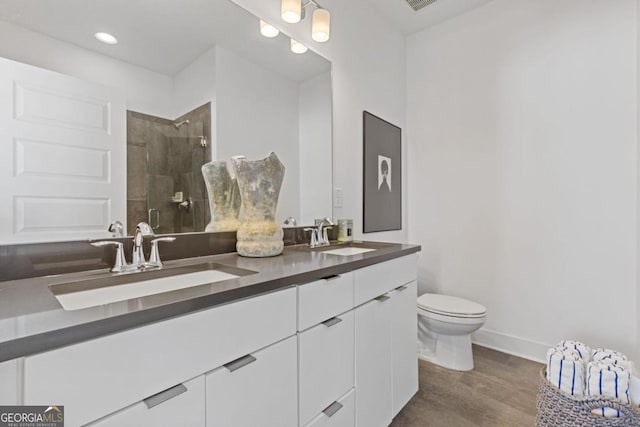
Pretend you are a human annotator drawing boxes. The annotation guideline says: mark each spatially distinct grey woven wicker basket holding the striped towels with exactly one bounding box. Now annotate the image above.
[536,368,640,427]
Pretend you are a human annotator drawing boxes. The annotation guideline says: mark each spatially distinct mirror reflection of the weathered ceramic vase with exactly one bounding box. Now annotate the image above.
[202,160,242,231]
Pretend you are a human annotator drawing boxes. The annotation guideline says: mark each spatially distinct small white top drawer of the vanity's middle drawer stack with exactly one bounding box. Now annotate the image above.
[298,272,353,331]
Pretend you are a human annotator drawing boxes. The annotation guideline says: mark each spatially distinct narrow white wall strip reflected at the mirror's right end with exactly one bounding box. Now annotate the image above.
[298,73,332,225]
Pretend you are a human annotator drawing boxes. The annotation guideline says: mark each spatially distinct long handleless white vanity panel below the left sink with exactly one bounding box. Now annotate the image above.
[24,288,296,425]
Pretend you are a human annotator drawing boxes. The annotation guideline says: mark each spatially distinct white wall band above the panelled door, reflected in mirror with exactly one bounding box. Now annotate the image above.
[0,21,173,117]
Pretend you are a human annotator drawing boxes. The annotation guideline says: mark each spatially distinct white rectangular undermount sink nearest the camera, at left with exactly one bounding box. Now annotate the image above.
[49,264,254,310]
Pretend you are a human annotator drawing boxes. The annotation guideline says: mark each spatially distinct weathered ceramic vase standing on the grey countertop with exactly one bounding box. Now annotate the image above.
[231,152,284,257]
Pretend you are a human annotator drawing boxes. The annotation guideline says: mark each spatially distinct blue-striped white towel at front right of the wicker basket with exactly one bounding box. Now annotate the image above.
[587,361,631,403]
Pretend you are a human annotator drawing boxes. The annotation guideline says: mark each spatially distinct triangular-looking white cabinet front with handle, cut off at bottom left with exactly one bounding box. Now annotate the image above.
[89,375,205,427]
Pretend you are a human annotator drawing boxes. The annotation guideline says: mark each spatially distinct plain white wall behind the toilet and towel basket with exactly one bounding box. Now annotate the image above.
[407,0,638,358]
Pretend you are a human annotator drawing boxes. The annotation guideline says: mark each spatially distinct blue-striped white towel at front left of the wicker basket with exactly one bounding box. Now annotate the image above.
[547,347,585,396]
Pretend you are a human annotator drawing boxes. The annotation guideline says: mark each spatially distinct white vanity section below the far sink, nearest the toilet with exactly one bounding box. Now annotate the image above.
[354,256,418,427]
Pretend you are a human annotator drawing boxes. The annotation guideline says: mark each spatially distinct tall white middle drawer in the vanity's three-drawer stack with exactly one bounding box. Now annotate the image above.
[298,310,354,425]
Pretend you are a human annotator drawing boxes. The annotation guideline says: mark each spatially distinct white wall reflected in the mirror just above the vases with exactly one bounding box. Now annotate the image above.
[213,46,300,223]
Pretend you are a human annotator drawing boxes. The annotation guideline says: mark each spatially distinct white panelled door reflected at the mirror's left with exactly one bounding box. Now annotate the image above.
[0,58,126,244]
